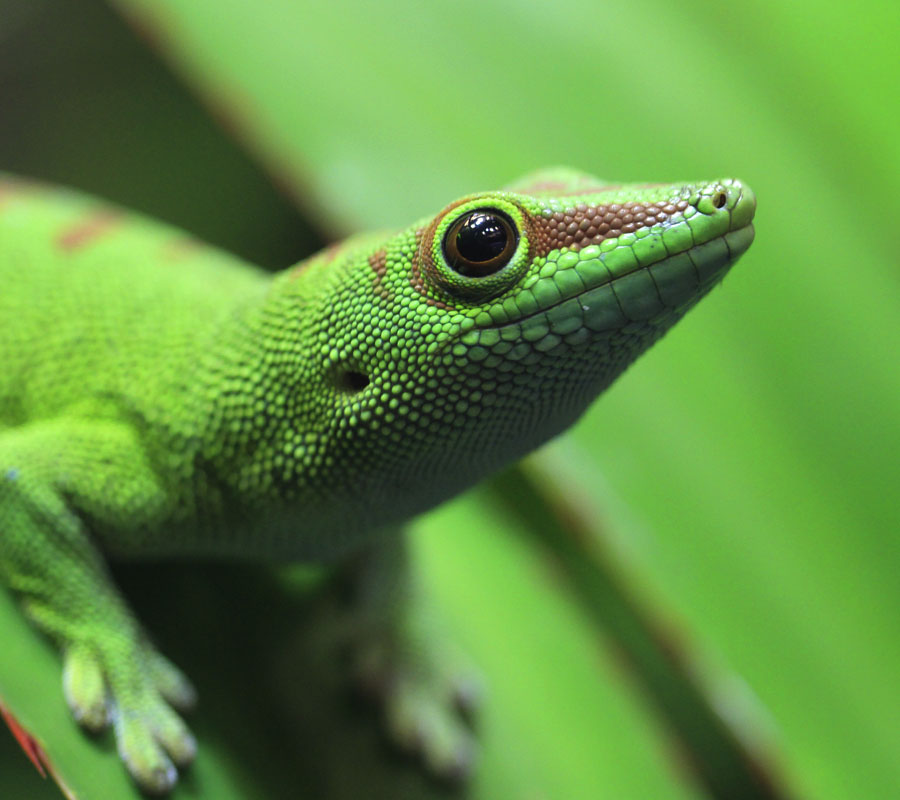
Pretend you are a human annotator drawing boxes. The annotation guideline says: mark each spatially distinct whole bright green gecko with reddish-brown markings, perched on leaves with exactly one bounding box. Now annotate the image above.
[0,169,756,793]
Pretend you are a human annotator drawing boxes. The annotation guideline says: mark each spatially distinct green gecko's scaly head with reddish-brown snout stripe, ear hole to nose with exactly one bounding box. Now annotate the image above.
[282,170,755,513]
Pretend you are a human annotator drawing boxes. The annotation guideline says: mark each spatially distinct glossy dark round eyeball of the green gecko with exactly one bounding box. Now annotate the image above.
[444,208,519,278]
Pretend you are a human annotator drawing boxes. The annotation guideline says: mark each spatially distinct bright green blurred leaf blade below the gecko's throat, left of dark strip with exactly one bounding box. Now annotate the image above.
[416,488,702,800]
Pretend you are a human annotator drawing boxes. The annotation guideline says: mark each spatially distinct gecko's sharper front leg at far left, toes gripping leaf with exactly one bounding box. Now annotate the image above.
[0,420,196,793]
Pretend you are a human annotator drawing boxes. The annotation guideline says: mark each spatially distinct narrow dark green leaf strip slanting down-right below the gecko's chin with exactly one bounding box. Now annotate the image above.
[490,456,788,800]
